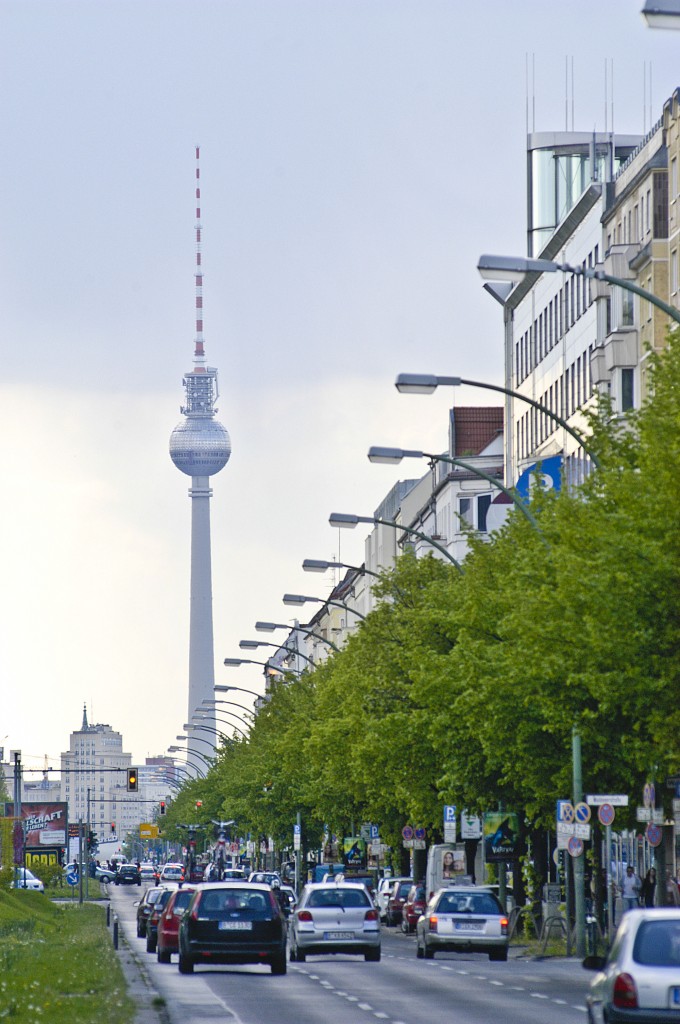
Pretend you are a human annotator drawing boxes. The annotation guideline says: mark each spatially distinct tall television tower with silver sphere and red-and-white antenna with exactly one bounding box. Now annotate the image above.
[170,146,231,768]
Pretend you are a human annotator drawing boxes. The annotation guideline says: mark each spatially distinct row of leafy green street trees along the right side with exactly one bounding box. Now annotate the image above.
[166,339,680,897]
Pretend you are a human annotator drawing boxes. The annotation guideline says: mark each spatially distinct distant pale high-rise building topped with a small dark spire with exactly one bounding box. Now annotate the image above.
[61,708,142,841]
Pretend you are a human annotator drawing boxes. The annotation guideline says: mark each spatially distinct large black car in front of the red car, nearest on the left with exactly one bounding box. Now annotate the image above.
[177,882,287,974]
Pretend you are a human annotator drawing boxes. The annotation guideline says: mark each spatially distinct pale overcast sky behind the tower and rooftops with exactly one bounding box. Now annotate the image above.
[0,0,680,764]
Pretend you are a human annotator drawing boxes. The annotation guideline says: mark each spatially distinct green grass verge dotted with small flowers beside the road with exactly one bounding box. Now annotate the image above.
[0,891,135,1024]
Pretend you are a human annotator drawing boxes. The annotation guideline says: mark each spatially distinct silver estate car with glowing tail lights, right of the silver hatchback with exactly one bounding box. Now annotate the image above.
[416,886,508,961]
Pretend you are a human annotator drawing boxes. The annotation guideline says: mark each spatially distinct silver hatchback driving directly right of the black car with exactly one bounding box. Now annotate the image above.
[289,882,380,963]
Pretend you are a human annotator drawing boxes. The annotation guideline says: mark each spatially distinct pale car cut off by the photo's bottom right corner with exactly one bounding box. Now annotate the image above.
[584,907,680,1024]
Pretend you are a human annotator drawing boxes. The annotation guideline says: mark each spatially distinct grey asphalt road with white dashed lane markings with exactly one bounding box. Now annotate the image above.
[109,886,591,1024]
